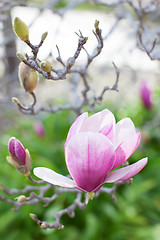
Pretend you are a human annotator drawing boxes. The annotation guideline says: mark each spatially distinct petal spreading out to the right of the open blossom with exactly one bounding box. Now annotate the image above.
[104,157,148,183]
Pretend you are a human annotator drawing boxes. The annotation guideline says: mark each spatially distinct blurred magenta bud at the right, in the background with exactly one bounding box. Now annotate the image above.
[140,80,153,109]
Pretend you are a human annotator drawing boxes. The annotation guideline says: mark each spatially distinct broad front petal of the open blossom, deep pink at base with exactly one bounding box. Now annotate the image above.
[65,132,115,192]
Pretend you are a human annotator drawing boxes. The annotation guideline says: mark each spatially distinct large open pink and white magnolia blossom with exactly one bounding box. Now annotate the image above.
[34,109,147,192]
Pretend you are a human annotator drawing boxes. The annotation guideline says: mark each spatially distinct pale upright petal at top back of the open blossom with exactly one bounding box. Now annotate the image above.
[80,109,115,132]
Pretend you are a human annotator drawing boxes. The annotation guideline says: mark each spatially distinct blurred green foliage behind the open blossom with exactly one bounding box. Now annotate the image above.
[0,85,160,240]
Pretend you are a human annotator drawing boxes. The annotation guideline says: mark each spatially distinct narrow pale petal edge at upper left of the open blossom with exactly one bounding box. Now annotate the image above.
[65,112,88,147]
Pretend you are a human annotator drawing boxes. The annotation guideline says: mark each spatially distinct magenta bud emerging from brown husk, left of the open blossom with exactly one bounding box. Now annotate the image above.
[7,137,31,176]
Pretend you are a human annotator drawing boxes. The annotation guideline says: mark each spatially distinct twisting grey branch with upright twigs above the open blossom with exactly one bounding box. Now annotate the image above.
[12,21,120,115]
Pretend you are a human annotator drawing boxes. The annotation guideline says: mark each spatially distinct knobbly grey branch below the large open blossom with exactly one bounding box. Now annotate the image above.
[0,173,131,229]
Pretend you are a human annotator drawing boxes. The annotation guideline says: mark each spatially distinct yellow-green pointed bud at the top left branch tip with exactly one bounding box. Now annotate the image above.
[14,17,29,41]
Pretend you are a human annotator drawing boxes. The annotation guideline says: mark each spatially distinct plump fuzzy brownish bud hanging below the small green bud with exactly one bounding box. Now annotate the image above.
[19,62,38,93]
